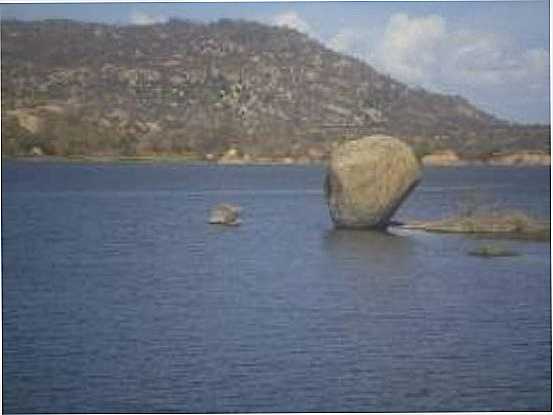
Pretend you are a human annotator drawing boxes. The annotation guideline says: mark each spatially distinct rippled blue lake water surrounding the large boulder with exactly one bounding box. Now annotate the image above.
[2,161,551,413]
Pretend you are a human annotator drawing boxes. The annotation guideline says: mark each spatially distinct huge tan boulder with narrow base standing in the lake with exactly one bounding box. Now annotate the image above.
[325,135,421,228]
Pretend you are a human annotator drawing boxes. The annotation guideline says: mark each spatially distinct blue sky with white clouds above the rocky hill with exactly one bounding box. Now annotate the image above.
[0,0,550,123]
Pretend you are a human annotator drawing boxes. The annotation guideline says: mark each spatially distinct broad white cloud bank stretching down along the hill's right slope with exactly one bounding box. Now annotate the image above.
[326,13,549,120]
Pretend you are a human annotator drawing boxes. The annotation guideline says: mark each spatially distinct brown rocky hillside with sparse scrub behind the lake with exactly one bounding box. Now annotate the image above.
[1,20,549,160]
